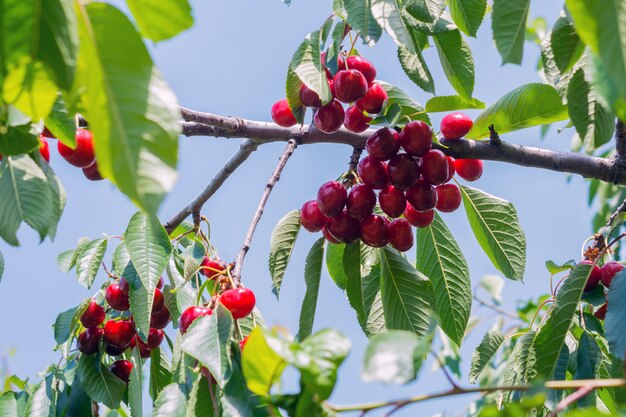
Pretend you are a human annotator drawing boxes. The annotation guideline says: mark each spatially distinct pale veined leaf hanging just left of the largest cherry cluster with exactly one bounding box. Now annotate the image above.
[269,210,300,298]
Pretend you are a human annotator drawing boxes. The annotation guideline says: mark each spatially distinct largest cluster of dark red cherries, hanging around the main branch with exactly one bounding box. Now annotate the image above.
[300,113,483,251]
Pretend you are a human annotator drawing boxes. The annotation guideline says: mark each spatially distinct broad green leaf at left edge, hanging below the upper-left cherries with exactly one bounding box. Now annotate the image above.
[0,155,52,246]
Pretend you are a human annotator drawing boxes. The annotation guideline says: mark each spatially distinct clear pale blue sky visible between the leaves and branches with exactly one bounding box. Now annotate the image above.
[0,0,592,417]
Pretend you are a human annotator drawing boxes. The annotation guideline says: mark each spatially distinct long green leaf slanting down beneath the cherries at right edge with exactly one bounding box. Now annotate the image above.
[533,265,591,378]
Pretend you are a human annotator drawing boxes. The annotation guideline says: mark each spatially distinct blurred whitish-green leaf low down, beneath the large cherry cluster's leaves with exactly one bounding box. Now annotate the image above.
[363,330,430,384]
